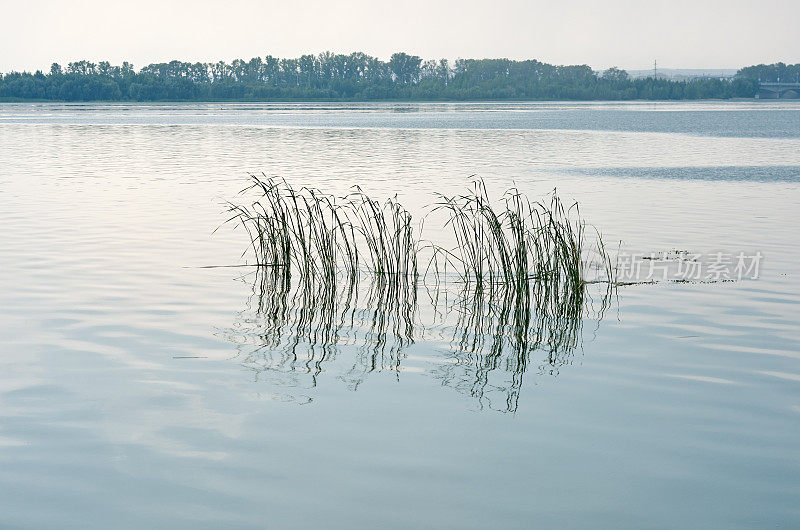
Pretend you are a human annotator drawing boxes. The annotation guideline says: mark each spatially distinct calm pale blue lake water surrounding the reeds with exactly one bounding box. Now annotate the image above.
[0,102,800,528]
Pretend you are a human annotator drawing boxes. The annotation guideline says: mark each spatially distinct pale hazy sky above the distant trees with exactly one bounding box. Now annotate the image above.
[0,0,800,72]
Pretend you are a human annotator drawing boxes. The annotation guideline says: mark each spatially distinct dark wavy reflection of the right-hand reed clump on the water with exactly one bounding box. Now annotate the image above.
[430,276,611,412]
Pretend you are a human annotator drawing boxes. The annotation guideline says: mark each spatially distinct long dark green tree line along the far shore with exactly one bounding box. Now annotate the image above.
[0,52,788,101]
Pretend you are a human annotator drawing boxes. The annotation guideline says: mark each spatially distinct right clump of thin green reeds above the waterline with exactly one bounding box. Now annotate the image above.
[434,180,611,292]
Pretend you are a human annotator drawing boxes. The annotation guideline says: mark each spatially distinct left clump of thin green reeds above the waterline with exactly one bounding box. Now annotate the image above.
[229,175,417,287]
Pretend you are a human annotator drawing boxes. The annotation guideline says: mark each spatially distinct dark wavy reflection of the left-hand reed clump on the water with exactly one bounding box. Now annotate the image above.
[231,268,418,389]
